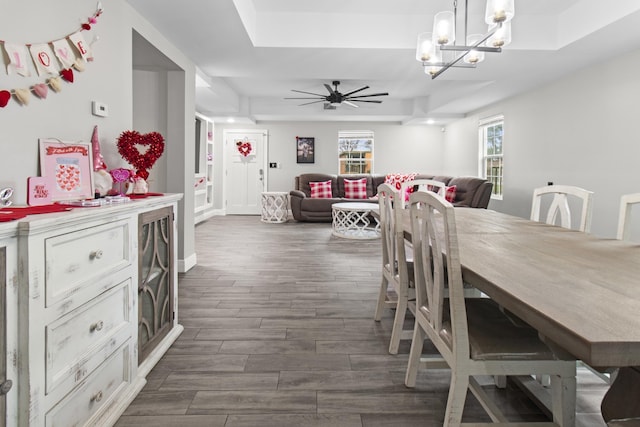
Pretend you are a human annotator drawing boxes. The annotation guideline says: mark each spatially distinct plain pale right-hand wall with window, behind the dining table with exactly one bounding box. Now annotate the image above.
[445,47,640,241]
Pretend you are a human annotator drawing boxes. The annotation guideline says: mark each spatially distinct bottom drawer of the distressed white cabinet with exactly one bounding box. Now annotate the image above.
[45,342,131,427]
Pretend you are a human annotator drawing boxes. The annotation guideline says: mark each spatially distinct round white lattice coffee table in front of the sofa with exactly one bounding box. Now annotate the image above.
[331,202,380,239]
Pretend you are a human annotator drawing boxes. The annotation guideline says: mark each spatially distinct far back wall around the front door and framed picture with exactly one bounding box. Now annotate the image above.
[214,122,444,208]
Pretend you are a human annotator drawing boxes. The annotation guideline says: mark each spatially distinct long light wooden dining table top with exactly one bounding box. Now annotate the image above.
[401,208,640,368]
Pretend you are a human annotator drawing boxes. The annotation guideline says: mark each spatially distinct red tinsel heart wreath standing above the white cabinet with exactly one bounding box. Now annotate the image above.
[118,130,164,179]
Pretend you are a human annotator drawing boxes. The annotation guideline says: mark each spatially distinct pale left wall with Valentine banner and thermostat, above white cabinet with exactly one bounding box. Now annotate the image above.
[0,0,195,268]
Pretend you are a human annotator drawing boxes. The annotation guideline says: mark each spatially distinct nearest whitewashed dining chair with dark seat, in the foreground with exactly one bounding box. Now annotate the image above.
[405,192,576,426]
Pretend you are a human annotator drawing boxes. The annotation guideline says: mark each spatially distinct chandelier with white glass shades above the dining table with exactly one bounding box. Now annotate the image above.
[416,0,514,79]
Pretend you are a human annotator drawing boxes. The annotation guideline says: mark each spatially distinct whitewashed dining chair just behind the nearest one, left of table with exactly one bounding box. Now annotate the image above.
[374,184,415,354]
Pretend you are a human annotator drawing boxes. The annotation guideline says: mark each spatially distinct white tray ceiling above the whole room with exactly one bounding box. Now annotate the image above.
[128,0,640,124]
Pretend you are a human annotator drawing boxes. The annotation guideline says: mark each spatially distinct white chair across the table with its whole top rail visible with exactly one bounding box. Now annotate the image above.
[531,185,593,233]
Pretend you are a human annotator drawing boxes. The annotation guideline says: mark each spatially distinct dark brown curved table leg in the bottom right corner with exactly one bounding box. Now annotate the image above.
[600,366,640,427]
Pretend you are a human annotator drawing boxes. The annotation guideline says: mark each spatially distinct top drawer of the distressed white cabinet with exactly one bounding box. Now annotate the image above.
[45,221,132,307]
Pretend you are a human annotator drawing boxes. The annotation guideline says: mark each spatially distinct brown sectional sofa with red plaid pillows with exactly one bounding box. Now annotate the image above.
[289,173,493,222]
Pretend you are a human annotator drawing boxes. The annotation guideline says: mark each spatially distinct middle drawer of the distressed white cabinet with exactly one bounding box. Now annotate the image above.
[46,280,133,394]
